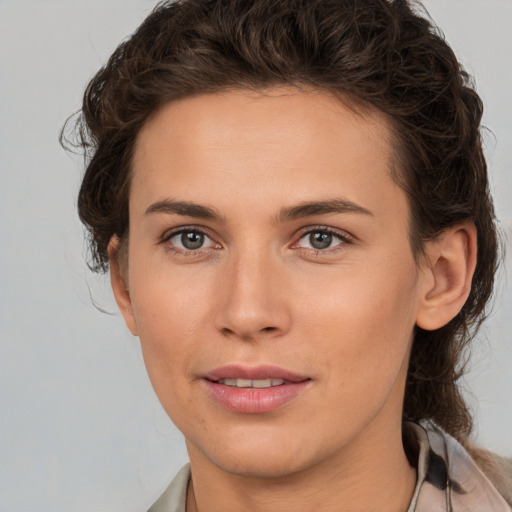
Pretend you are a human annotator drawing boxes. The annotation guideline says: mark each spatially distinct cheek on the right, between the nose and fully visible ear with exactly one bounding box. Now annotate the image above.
[296,254,417,382]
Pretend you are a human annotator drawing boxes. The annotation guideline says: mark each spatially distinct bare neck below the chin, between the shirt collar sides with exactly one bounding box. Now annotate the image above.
[187,420,416,512]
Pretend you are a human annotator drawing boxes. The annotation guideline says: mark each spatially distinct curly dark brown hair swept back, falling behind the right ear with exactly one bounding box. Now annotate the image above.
[64,0,499,441]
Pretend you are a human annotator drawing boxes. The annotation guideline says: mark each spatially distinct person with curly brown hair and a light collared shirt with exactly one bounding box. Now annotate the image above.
[64,0,512,512]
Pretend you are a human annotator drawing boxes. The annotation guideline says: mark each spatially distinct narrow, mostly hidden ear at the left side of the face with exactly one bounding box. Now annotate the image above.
[108,235,138,336]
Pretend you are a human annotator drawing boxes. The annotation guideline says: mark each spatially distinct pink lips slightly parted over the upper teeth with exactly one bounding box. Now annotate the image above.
[202,365,311,414]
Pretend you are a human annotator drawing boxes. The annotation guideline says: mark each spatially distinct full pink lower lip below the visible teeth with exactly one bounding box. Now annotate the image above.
[203,379,311,414]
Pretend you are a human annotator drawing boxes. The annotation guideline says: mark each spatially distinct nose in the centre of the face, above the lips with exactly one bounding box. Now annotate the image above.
[215,247,291,341]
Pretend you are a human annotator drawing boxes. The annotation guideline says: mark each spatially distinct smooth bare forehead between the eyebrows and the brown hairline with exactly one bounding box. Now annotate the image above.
[131,87,401,222]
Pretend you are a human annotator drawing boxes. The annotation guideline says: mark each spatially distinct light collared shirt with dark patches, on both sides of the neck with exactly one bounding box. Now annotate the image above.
[148,421,512,512]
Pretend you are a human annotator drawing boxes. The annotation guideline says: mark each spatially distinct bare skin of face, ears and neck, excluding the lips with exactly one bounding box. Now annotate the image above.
[110,88,476,512]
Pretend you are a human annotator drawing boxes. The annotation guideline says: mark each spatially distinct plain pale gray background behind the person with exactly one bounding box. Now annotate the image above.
[0,0,512,512]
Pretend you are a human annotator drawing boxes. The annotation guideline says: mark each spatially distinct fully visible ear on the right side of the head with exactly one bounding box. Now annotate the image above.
[416,222,477,331]
